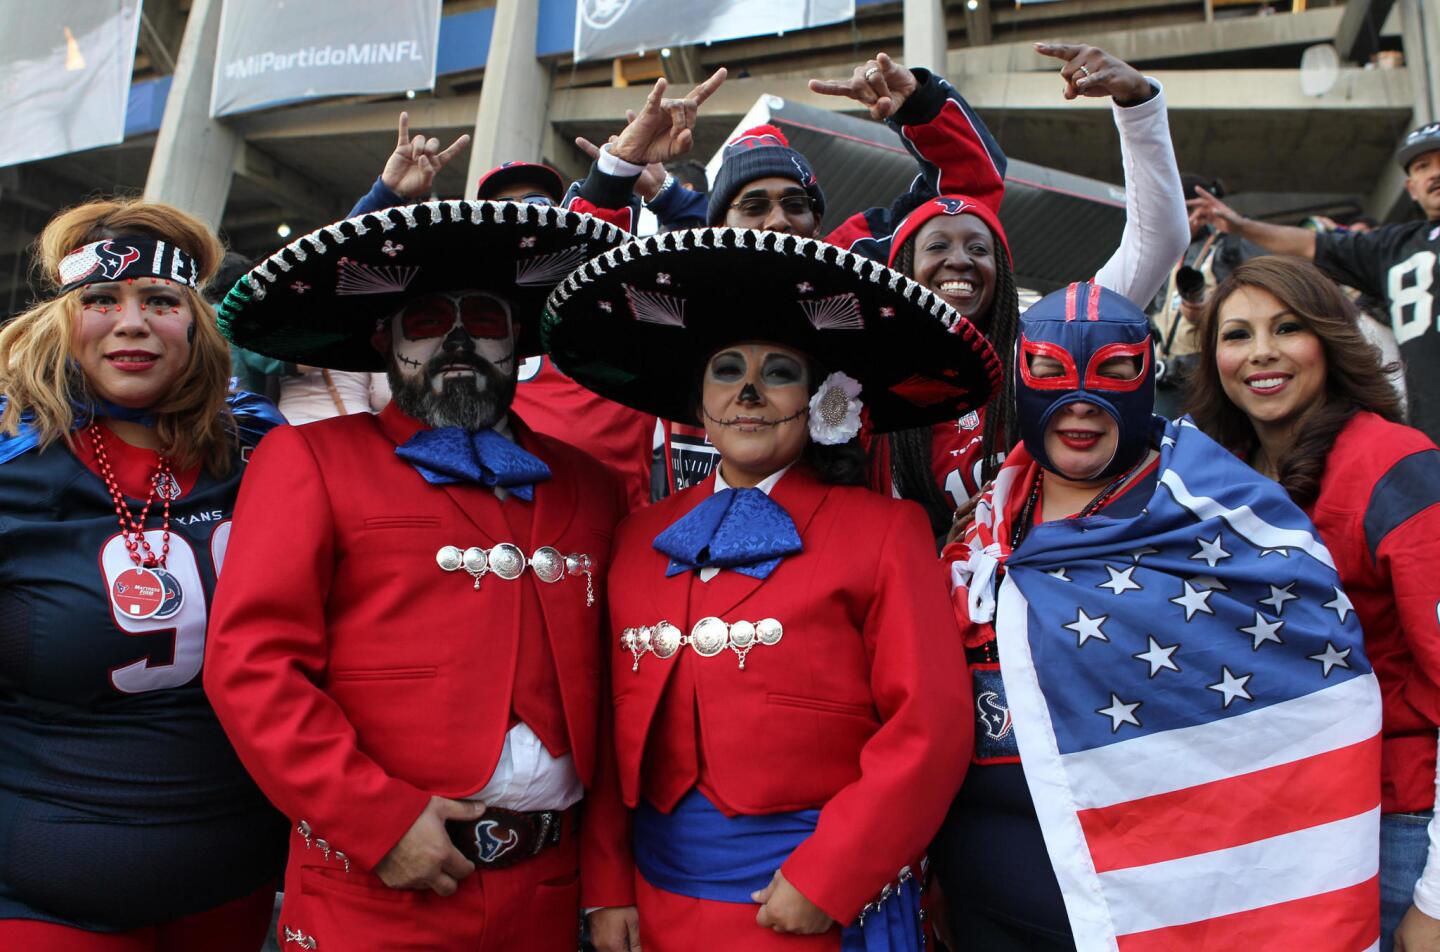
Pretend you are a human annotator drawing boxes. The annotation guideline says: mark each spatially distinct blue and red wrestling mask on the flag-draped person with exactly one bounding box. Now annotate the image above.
[1015,282,1155,478]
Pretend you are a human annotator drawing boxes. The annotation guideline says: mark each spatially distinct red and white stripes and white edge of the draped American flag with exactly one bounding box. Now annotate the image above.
[995,578,1381,952]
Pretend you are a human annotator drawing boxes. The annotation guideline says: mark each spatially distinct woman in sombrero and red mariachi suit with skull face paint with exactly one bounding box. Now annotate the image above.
[547,229,999,952]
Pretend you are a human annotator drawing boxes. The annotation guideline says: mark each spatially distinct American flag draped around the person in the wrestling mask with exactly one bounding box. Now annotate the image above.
[952,419,1381,952]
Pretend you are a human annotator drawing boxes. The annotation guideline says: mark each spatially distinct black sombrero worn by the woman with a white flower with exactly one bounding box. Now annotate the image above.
[543,228,1001,432]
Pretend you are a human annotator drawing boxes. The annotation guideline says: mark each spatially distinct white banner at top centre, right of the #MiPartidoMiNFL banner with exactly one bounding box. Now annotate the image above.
[575,0,855,62]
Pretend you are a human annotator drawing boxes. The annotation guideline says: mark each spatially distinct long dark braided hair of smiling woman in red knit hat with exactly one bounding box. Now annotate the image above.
[888,218,1020,534]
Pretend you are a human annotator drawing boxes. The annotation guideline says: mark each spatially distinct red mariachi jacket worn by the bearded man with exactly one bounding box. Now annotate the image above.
[204,405,622,879]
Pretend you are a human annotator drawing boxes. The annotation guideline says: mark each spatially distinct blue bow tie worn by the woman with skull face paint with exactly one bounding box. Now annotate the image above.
[652,490,804,579]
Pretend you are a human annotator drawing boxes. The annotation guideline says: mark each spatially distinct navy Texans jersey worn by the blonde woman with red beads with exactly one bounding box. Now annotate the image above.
[0,423,287,932]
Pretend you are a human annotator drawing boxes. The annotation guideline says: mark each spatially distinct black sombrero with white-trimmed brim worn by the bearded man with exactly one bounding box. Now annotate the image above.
[216,202,626,370]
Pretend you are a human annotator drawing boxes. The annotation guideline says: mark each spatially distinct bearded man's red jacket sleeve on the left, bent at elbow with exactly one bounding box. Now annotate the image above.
[204,426,429,868]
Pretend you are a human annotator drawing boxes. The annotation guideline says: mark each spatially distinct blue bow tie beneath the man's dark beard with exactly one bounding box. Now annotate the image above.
[395,426,550,501]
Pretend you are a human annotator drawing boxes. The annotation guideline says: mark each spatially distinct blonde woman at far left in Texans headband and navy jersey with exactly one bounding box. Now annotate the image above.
[0,200,287,952]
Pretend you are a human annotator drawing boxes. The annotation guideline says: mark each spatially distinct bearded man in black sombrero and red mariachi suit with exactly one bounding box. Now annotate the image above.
[204,202,621,952]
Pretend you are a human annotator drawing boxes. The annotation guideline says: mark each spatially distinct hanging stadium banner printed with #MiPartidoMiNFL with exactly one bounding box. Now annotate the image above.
[210,0,441,117]
